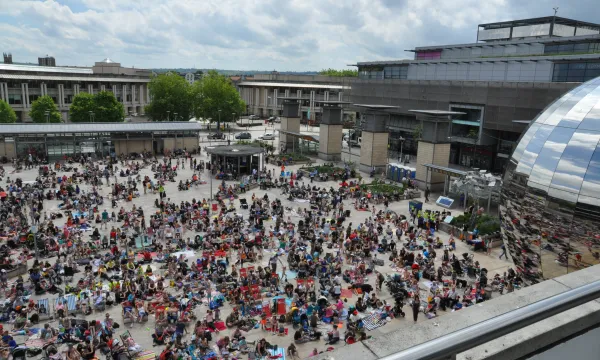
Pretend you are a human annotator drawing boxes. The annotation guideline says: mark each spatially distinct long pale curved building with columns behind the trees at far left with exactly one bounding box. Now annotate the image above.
[0,58,151,122]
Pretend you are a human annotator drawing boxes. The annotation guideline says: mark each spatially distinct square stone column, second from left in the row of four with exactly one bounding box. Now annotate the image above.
[319,103,344,161]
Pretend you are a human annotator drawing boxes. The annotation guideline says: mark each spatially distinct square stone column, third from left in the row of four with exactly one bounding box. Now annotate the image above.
[359,112,389,173]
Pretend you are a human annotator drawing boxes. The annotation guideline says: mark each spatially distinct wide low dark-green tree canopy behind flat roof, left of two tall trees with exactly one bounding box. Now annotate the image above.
[69,91,125,122]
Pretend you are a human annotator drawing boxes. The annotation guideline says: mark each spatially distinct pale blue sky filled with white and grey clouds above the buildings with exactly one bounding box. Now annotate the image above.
[0,0,600,71]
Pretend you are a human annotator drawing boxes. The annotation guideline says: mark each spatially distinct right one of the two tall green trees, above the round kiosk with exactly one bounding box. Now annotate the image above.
[192,70,246,131]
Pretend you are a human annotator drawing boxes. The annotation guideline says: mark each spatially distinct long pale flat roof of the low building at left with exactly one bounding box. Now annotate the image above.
[0,121,202,135]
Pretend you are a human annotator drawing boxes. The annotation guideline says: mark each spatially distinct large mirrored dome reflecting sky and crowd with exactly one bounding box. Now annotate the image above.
[500,77,600,284]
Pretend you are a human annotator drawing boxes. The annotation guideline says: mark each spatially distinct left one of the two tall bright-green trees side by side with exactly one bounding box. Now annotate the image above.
[145,72,192,121]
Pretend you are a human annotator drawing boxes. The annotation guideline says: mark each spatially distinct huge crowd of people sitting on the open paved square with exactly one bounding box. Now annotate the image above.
[0,151,521,360]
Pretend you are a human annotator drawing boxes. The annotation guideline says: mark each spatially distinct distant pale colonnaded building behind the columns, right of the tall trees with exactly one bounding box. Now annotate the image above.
[237,74,351,123]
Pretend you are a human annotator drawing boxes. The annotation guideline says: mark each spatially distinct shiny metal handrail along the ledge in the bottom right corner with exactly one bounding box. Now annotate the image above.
[381,281,600,360]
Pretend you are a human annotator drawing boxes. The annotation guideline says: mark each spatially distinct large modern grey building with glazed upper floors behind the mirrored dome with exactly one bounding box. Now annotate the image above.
[351,17,600,172]
